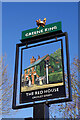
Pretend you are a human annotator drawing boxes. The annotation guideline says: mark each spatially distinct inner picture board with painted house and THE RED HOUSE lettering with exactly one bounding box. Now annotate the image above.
[20,40,66,103]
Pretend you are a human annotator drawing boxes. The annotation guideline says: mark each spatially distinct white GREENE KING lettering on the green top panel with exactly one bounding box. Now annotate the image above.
[25,26,57,37]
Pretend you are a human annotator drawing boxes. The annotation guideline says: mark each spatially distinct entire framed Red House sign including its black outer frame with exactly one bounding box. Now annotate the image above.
[12,32,72,109]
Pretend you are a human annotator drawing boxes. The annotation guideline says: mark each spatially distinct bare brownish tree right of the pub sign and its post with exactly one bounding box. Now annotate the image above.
[50,58,80,118]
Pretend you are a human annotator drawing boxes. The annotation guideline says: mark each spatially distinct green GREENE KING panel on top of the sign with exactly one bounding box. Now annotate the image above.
[22,22,62,40]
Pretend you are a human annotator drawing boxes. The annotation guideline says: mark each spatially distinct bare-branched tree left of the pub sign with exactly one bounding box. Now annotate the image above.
[0,56,17,115]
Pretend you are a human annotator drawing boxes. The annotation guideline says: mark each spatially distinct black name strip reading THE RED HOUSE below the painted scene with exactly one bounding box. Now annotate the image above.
[20,85,66,103]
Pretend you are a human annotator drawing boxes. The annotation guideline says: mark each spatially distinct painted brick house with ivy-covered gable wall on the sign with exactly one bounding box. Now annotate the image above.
[22,54,62,86]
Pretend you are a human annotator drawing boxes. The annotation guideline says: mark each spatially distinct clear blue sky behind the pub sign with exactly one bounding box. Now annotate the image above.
[2,2,78,118]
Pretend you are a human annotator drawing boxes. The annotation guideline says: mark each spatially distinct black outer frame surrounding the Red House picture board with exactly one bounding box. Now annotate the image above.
[12,32,72,109]
